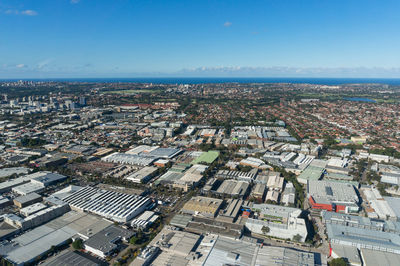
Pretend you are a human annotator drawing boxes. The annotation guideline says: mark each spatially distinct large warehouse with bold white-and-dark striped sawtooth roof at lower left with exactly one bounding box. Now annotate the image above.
[63,186,151,223]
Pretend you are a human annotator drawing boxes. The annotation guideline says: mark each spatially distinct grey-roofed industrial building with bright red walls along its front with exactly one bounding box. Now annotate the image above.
[307,180,359,213]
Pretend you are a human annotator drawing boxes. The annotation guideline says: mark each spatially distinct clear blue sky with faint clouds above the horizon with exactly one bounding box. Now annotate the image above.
[0,0,400,78]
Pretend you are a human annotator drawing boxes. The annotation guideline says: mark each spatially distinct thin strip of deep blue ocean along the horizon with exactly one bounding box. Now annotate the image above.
[0,77,400,86]
